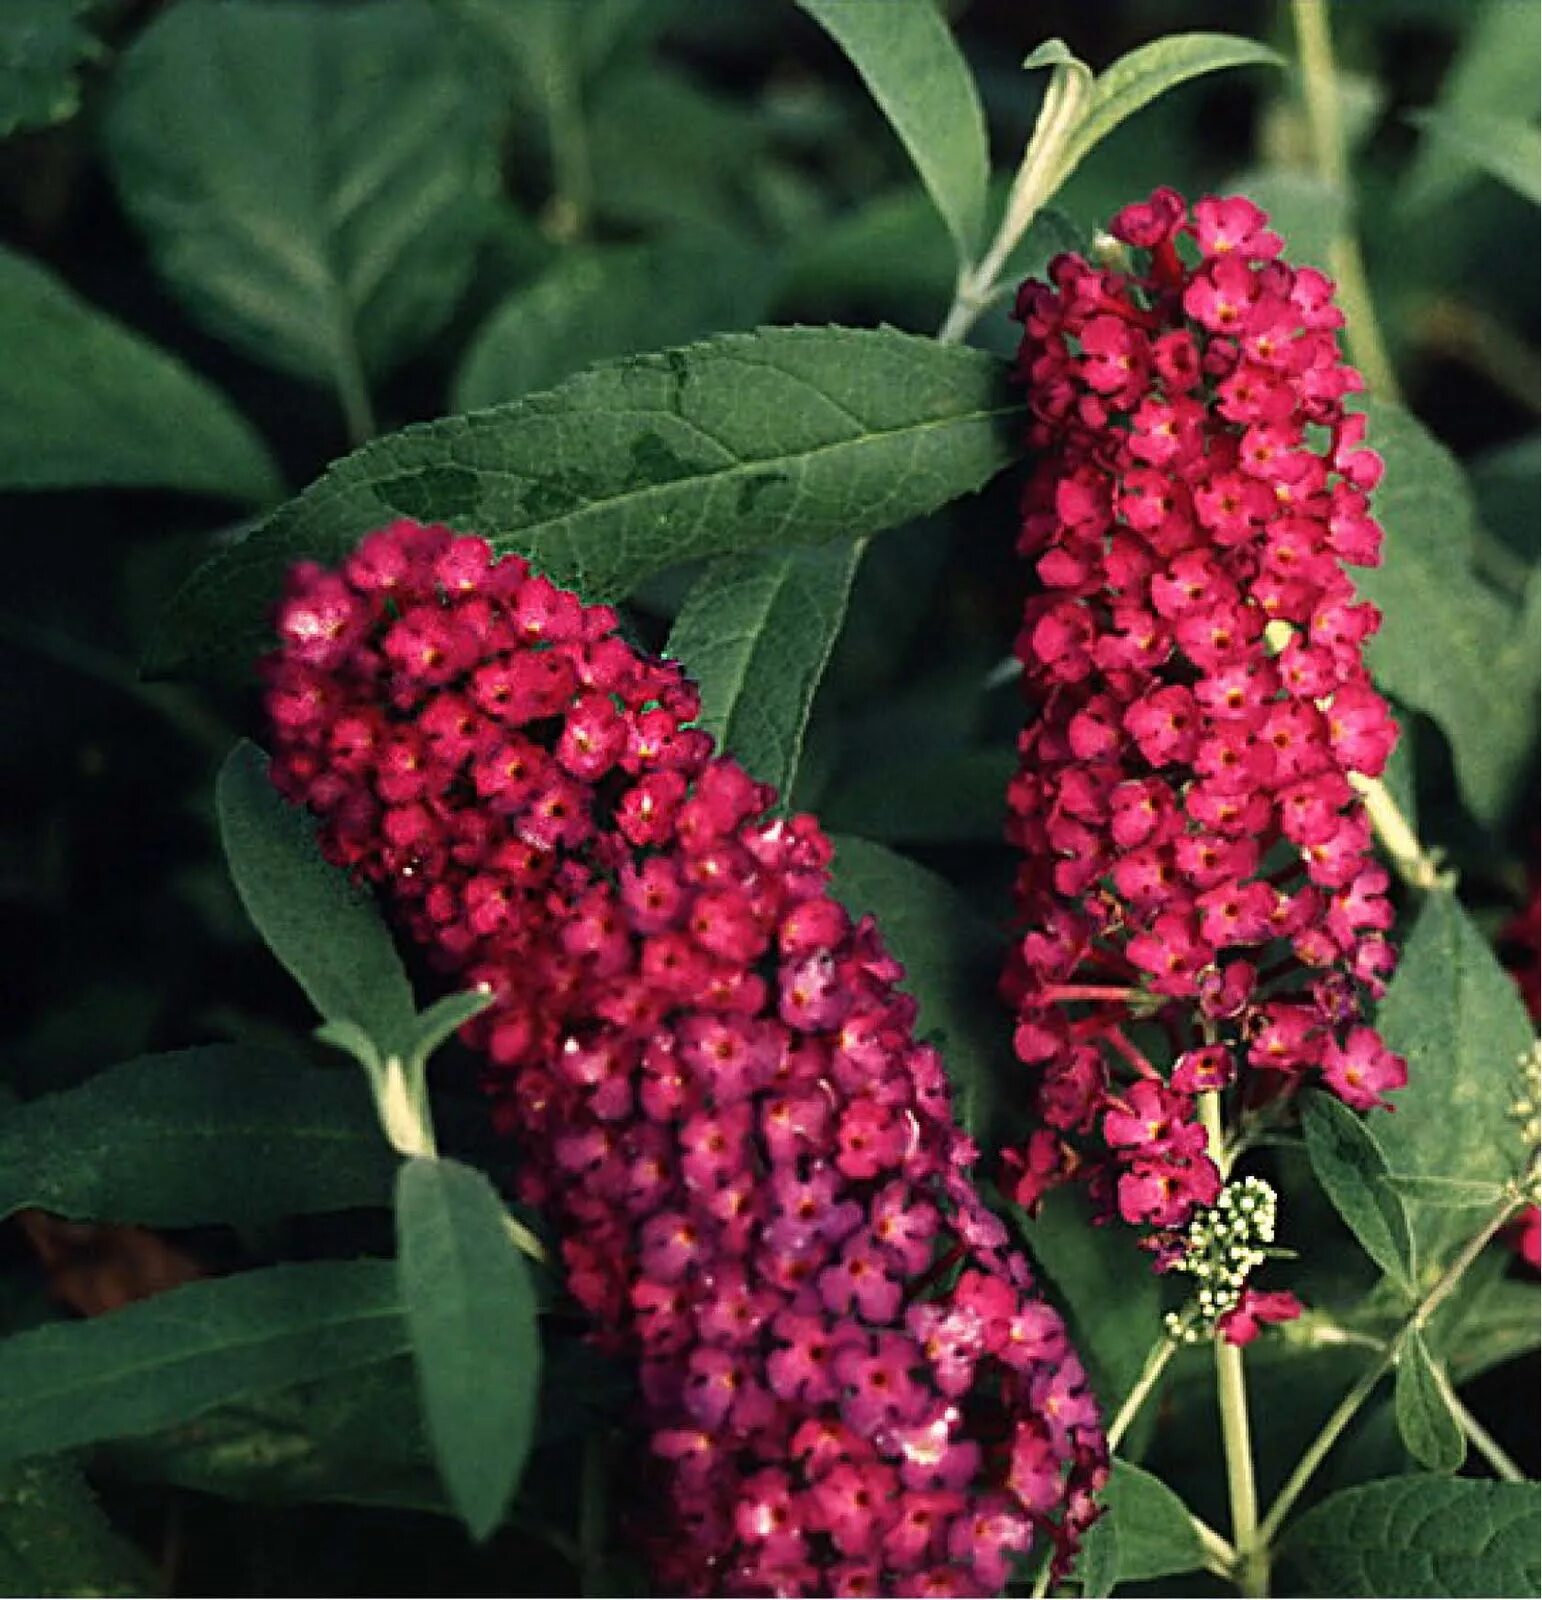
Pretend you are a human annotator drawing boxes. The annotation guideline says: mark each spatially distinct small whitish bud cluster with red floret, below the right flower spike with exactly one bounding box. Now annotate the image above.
[1166,1178,1300,1344]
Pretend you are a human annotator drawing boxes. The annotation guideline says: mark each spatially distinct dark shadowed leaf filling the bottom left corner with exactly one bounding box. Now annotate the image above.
[0,1461,162,1595]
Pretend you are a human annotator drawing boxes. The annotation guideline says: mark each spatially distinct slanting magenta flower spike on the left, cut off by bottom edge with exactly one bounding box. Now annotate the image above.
[264,522,1107,1595]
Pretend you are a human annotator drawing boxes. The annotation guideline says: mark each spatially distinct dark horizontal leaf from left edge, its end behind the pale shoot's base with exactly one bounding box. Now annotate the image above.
[0,1045,395,1227]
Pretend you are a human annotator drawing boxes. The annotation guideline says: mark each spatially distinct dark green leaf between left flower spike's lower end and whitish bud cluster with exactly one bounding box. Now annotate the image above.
[1013,1189,1163,1416]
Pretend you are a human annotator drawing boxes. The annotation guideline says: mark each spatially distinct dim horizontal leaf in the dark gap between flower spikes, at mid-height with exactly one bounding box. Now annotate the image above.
[819,746,1017,845]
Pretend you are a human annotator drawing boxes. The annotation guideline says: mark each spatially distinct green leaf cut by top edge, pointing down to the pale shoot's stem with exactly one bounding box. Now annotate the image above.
[798,0,990,261]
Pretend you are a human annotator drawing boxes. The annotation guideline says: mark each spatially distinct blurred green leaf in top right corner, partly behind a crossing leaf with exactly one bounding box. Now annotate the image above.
[1396,0,1539,211]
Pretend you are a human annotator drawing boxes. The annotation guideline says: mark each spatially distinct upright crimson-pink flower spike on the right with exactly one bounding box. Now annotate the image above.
[1003,189,1406,1261]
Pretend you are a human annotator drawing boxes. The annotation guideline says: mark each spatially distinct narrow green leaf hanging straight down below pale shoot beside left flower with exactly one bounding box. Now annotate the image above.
[397,1158,541,1539]
